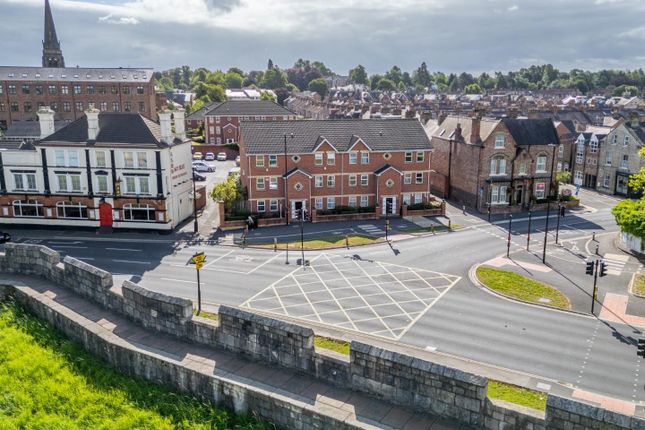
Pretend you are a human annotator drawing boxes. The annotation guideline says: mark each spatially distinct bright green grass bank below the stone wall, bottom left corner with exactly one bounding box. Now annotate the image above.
[0,303,275,430]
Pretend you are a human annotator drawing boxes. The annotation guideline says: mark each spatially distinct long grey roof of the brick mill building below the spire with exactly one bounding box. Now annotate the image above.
[0,66,154,84]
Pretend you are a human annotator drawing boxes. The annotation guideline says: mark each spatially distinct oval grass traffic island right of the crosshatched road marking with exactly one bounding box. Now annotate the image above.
[477,267,571,309]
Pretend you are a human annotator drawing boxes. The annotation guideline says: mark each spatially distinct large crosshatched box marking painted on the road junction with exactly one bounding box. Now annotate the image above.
[242,255,461,339]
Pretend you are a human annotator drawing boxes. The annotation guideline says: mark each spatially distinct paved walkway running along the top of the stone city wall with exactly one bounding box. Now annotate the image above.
[0,274,463,430]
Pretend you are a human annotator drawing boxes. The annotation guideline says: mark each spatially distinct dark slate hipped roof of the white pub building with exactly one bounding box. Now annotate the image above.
[37,112,178,147]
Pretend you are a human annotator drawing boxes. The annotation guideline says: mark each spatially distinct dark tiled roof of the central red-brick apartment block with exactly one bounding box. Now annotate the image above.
[241,119,431,154]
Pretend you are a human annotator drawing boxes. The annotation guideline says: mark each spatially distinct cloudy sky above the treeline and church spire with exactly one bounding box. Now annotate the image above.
[0,0,645,74]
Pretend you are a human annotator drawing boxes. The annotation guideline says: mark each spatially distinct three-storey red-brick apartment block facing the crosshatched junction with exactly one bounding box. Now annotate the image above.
[240,120,432,219]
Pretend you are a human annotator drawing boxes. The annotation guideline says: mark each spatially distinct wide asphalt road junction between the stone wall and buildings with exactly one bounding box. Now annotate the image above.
[3,198,645,402]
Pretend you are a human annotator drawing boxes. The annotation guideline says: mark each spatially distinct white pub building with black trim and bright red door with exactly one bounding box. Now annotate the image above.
[0,107,192,230]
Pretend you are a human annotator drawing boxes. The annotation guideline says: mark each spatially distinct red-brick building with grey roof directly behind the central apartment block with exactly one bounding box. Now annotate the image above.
[204,100,296,145]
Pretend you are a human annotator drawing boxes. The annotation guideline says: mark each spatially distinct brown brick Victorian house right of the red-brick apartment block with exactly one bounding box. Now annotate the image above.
[432,116,560,212]
